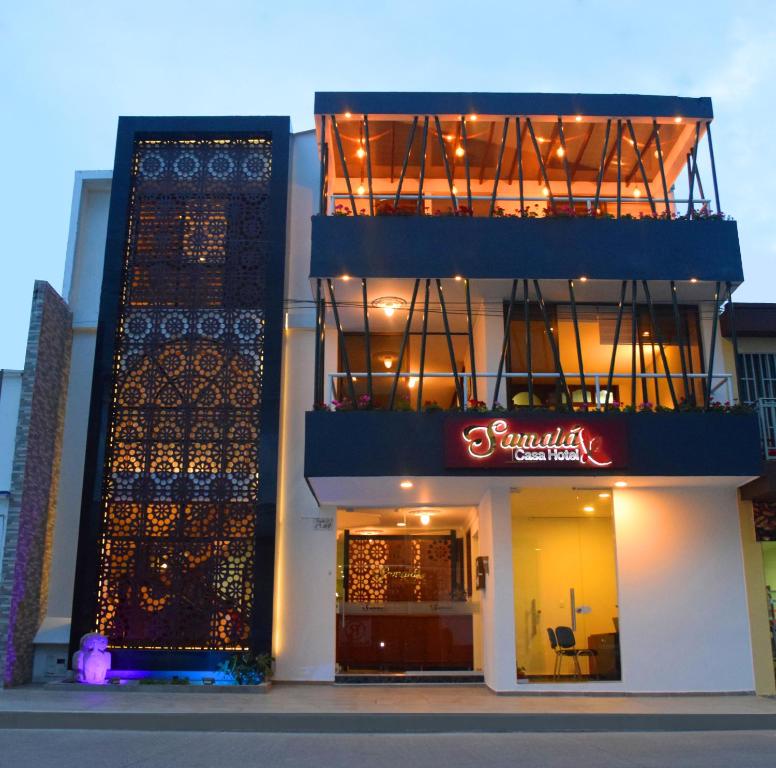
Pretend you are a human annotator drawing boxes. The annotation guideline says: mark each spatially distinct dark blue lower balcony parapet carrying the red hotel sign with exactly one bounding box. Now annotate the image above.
[305,409,761,480]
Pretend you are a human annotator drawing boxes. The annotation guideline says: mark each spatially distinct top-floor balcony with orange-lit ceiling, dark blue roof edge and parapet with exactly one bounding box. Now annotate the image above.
[311,93,742,283]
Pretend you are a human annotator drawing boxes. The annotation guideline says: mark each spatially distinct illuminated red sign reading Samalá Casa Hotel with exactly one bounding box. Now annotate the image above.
[445,416,627,472]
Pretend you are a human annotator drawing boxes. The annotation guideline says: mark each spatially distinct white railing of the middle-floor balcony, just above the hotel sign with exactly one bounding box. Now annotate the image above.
[326,371,732,414]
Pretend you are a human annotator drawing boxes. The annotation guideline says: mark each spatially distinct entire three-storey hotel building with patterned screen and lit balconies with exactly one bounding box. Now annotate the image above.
[3,93,774,693]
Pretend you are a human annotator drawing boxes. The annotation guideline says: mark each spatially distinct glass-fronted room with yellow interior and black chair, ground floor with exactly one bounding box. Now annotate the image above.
[511,488,621,683]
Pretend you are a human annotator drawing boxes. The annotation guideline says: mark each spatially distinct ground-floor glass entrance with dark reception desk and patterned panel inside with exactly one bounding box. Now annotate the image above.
[337,507,480,675]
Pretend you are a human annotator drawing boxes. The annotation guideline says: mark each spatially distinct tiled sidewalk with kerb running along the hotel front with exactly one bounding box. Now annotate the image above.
[0,683,776,733]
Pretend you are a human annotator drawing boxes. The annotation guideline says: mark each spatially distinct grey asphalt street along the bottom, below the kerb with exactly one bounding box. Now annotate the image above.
[0,730,776,768]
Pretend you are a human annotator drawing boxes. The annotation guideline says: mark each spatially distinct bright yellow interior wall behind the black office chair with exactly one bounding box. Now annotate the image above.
[512,517,617,675]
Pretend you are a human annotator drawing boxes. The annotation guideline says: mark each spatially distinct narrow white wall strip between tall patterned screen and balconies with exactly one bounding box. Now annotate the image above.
[273,131,337,681]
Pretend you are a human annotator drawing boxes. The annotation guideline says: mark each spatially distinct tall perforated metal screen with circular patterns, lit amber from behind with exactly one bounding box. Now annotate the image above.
[96,138,272,650]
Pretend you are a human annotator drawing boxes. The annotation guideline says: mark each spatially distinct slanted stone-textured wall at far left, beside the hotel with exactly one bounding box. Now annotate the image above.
[0,281,72,686]
